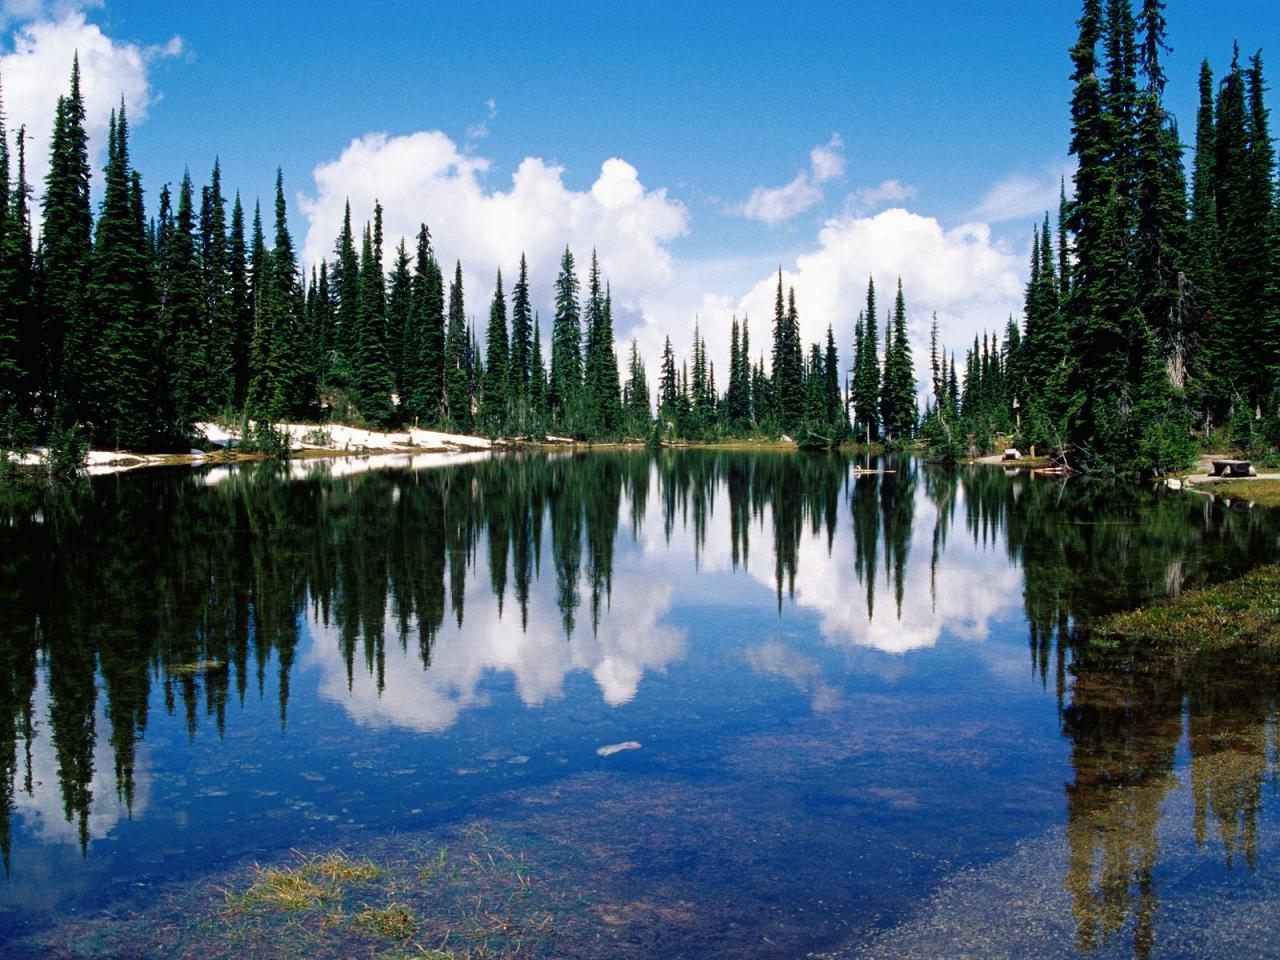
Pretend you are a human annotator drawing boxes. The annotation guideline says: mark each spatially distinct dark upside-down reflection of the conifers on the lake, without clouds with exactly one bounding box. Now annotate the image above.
[0,451,1280,956]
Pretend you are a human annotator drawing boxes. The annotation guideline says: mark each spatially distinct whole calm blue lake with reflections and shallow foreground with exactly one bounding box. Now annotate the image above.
[0,451,1280,957]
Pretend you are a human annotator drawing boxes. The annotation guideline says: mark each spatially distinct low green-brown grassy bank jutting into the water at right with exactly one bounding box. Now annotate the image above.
[1092,564,1280,653]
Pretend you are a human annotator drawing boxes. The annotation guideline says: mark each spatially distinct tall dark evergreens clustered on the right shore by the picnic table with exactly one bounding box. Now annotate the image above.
[925,0,1280,472]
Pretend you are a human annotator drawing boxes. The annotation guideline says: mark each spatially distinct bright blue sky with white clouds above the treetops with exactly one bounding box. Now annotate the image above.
[0,0,1280,383]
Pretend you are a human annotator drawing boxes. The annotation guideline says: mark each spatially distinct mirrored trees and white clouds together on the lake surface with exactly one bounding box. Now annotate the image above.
[0,451,1280,955]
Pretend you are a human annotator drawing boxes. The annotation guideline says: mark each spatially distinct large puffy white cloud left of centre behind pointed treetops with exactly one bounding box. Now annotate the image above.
[300,131,689,317]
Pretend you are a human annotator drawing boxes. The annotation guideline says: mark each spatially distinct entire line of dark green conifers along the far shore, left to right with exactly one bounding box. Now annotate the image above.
[0,0,1280,474]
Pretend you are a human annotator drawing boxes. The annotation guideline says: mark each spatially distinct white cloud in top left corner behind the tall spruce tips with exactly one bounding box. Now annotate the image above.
[0,3,183,206]
